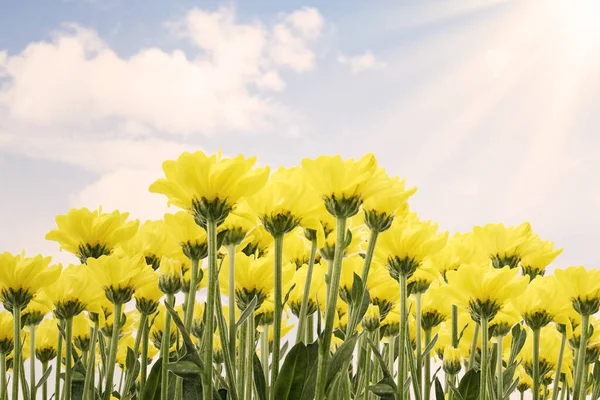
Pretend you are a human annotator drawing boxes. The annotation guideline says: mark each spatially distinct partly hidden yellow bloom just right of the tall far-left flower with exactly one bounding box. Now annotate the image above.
[118,220,183,270]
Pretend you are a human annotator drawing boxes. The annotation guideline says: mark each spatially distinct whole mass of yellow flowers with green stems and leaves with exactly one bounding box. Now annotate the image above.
[0,152,600,400]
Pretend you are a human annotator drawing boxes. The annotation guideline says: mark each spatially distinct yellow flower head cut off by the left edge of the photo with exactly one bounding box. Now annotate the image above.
[0,253,60,310]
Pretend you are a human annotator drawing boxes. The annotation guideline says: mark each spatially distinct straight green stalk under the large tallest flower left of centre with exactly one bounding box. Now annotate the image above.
[202,219,219,399]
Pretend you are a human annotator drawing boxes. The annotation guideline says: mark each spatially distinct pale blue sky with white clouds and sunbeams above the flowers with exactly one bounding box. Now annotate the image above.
[0,0,600,267]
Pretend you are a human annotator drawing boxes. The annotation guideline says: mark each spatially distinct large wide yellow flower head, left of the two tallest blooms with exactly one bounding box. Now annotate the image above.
[150,151,269,222]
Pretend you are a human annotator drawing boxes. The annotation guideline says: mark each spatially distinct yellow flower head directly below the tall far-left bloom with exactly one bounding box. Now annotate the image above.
[44,266,106,319]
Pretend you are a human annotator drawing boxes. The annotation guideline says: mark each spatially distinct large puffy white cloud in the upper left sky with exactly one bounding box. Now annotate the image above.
[0,8,323,135]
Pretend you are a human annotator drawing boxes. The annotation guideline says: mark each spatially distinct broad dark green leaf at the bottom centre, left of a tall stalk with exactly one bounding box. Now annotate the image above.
[273,342,308,400]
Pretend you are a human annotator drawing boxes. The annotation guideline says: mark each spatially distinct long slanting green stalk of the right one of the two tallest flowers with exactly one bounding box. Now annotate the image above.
[316,217,346,400]
